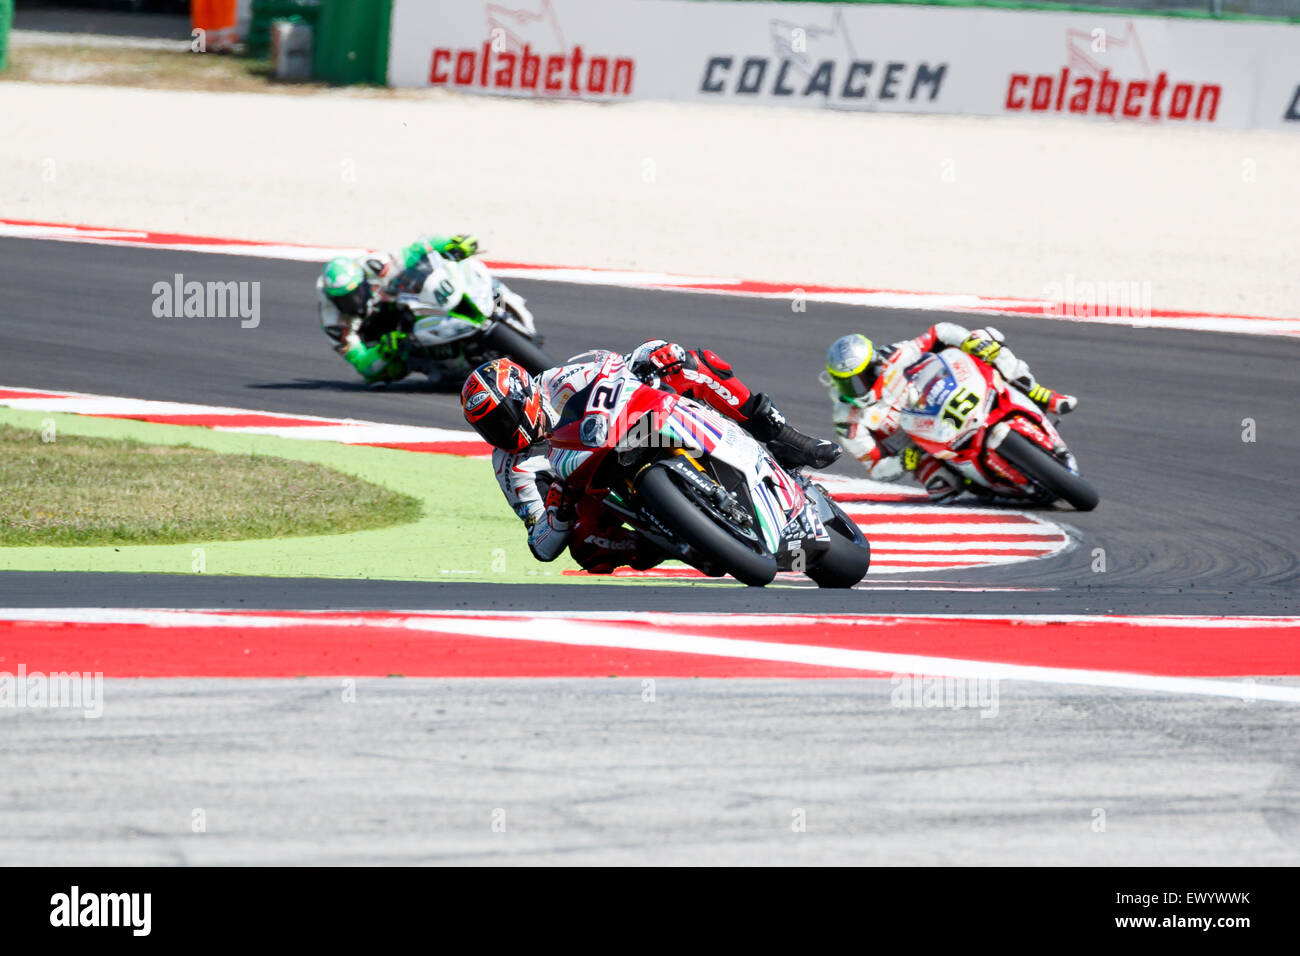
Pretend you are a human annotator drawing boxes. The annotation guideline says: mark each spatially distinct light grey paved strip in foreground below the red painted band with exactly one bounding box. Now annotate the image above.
[0,679,1300,866]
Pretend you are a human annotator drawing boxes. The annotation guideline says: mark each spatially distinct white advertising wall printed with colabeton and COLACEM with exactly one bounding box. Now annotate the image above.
[387,0,1300,130]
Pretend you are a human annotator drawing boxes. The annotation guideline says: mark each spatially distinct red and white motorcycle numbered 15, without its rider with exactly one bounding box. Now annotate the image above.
[897,349,1100,511]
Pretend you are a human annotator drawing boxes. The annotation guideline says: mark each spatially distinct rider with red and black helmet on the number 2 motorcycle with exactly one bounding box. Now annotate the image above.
[460,338,840,574]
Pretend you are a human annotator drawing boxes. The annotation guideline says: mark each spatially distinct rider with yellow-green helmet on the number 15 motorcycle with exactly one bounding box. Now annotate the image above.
[822,323,1079,501]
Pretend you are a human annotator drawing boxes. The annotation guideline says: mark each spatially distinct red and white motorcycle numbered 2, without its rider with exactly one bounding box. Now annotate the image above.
[550,351,871,588]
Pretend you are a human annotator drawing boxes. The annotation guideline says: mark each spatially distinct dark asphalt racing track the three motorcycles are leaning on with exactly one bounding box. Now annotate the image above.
[0,239,1300,614]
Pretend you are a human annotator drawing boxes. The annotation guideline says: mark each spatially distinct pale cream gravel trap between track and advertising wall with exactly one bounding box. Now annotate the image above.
[0,82,1300,316]
